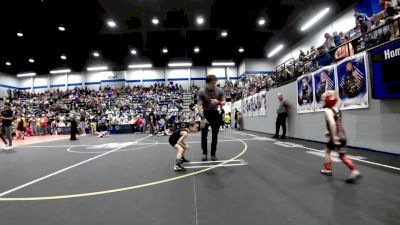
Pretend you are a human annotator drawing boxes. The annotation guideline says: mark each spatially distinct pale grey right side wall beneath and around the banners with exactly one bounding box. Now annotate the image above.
[238,77,400,154]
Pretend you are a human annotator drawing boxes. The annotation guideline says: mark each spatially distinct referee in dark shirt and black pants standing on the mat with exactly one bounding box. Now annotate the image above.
[197,75,225,161]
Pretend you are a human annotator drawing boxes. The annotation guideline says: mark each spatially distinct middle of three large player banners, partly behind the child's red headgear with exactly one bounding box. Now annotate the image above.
[313,66,337,111]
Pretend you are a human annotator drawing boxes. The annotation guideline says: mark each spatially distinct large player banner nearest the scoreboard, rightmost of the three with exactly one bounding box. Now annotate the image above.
[336,53,369,110]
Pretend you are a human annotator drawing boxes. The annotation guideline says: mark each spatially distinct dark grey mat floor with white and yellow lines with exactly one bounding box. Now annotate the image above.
[0,130,400,225]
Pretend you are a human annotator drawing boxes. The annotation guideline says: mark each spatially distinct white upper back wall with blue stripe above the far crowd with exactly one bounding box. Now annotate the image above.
[0,67,238,92]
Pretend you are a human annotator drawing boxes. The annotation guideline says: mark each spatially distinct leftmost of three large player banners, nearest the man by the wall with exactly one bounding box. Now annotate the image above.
[297,74,314,113]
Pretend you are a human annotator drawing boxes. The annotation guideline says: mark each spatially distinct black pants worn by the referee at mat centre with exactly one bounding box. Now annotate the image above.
[201,110,221,156]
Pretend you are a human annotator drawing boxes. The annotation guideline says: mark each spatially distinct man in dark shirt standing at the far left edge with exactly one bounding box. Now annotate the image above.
[0,103,14,150]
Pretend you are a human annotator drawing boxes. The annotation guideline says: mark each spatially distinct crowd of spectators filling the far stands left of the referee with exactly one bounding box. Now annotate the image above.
[0,82,183,139]
